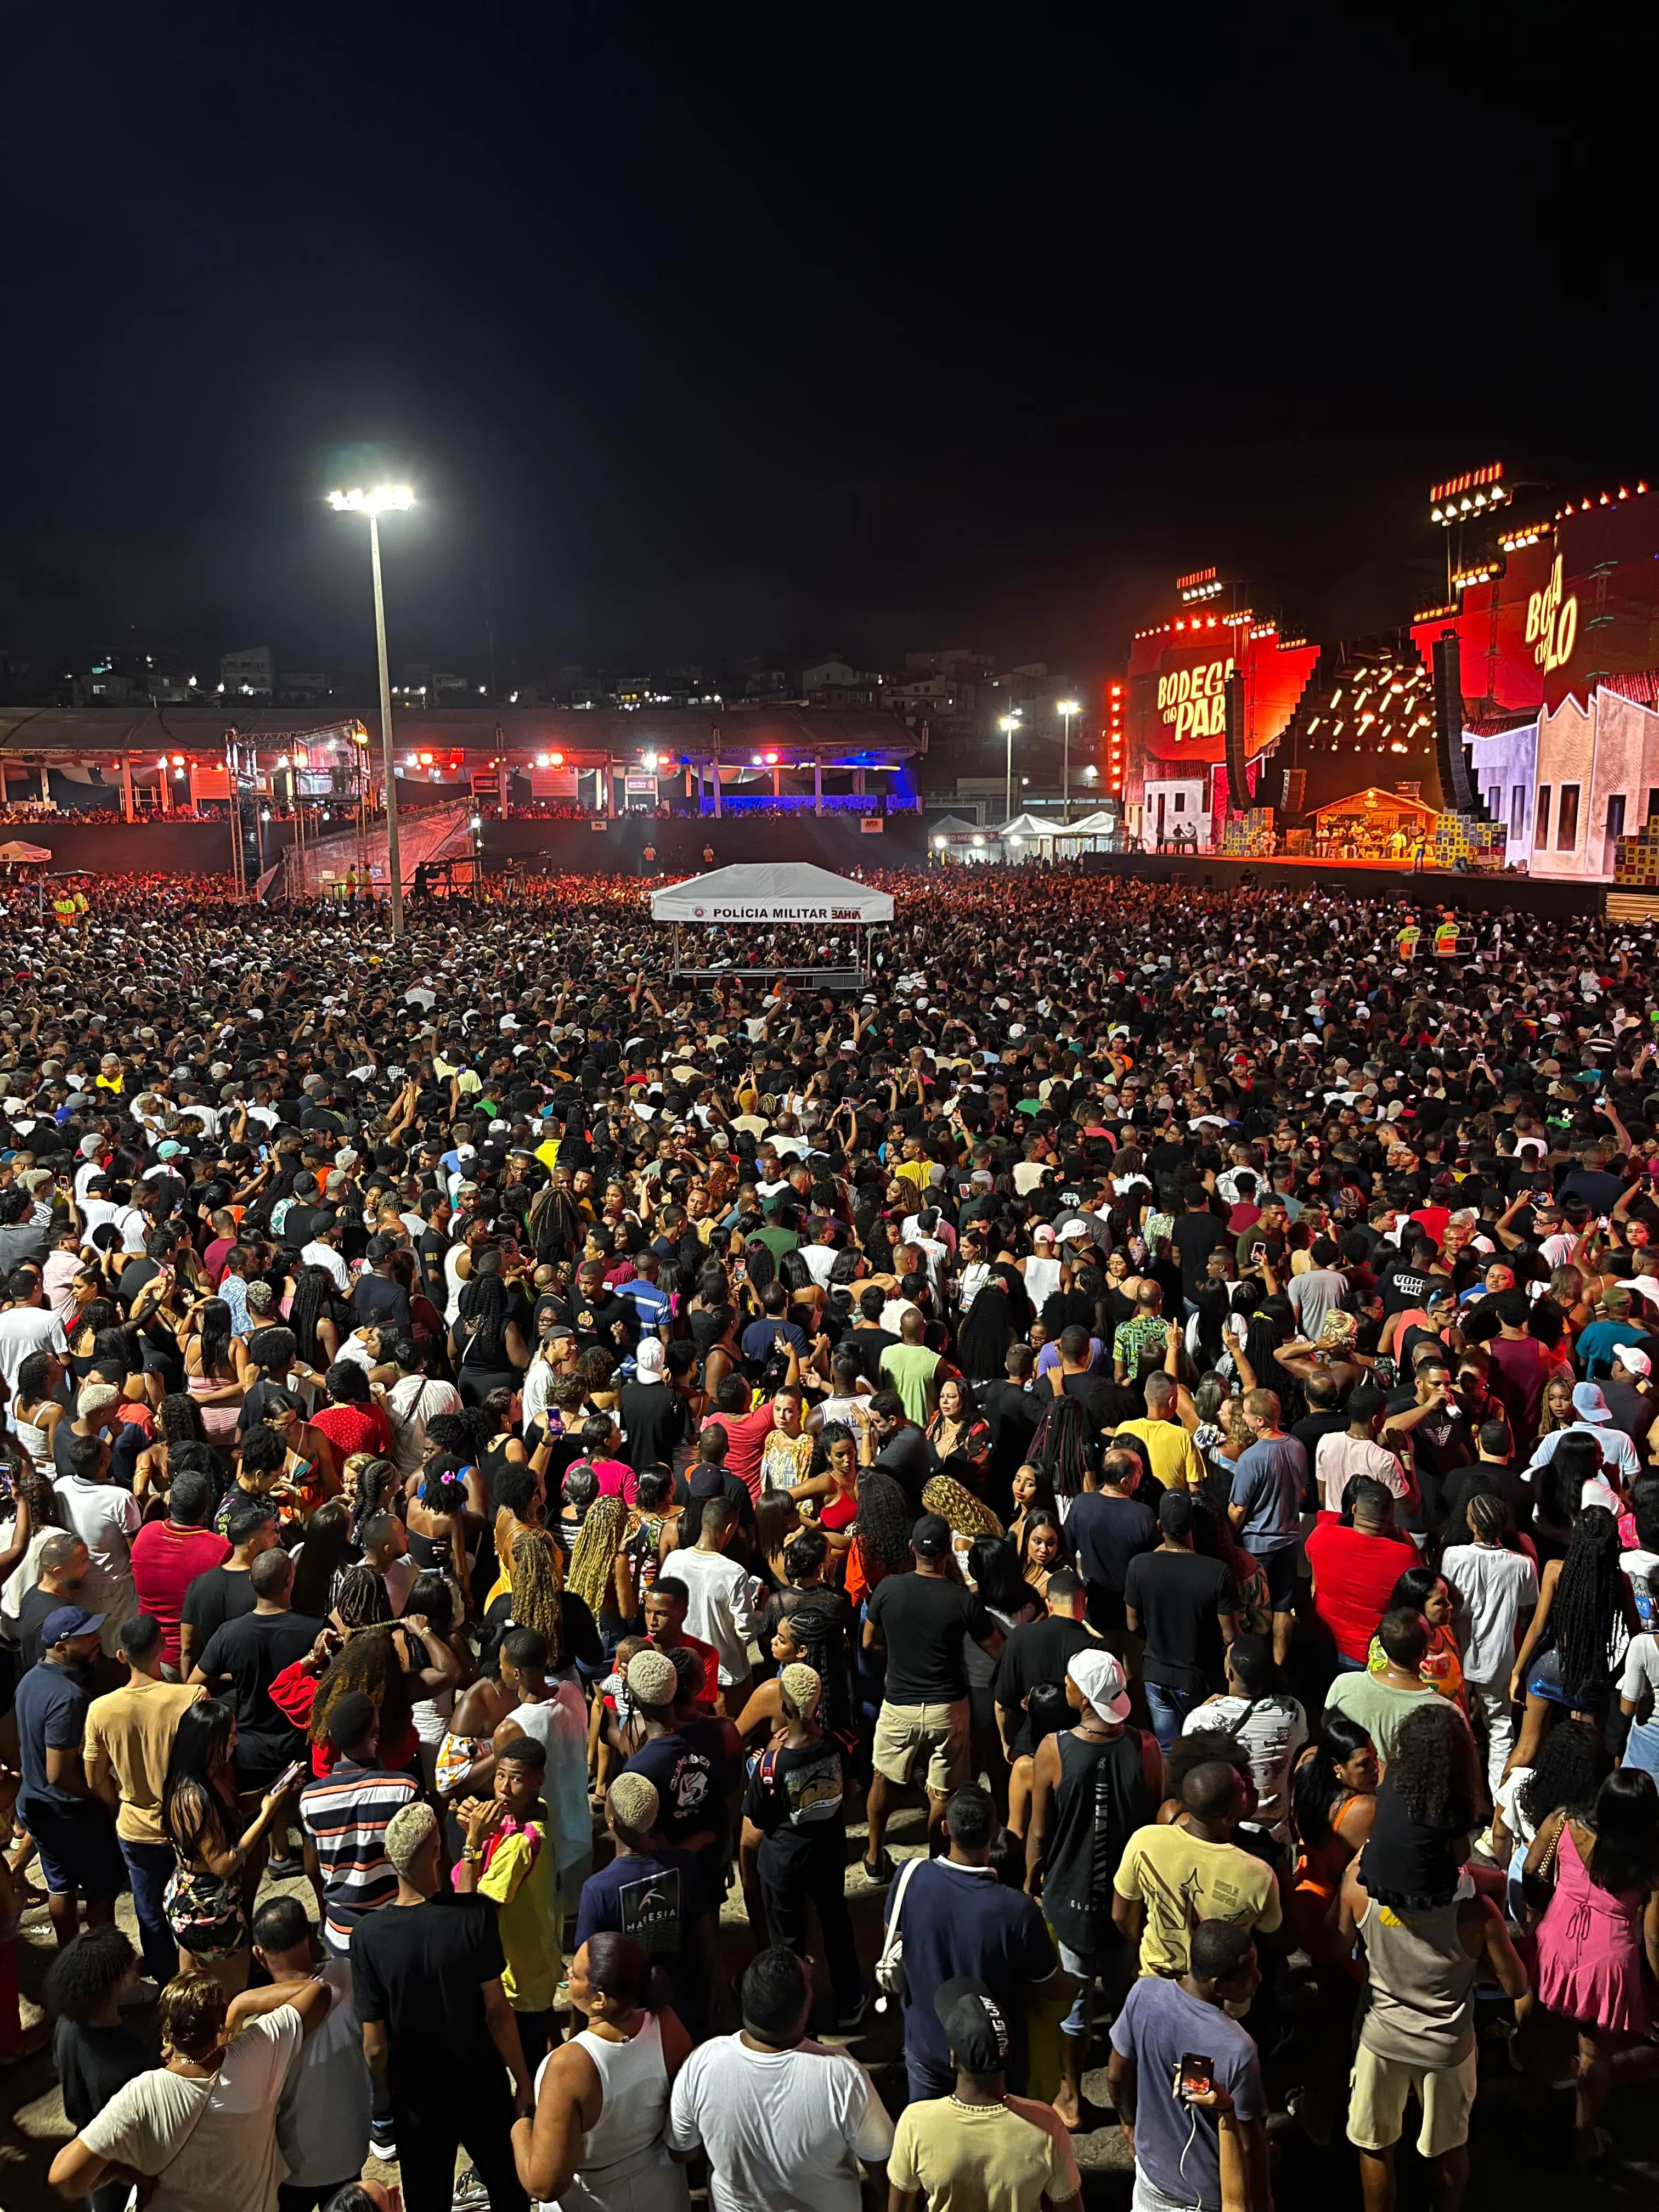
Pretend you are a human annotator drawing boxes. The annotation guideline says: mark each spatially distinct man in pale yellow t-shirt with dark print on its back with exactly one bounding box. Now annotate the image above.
[1113,1758,1281,1973]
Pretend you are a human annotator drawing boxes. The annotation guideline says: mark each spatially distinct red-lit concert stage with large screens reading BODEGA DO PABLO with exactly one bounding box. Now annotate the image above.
[1119,462,1659,891]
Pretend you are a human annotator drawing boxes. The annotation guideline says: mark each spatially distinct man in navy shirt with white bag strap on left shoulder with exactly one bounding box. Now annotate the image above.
[887,1783,1068,2101]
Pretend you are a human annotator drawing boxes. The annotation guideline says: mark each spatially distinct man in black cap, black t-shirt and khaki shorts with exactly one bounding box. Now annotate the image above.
[865,1513,1002,1882]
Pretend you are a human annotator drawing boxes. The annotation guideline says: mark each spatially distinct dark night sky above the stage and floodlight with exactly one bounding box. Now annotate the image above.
[0,0,1659,677]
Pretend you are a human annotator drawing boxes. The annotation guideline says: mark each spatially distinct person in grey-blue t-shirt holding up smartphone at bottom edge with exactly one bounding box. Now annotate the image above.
[1106,1920,1272,2212]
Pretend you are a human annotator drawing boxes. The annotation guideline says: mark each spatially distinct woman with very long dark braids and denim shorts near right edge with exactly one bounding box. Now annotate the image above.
[1504,1495,1641,1772]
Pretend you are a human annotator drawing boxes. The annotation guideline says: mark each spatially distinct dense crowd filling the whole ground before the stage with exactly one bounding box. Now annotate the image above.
[0,870,1659,2212]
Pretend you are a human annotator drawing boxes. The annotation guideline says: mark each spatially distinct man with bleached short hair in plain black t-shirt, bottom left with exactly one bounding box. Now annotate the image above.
[352,1801,533,2212]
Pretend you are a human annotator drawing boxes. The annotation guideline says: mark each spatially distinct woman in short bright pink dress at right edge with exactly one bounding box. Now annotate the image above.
[1526,1768,1659,2159]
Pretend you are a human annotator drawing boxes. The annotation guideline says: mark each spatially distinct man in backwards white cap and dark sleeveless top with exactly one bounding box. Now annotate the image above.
[1026,1648,1164,2128]
